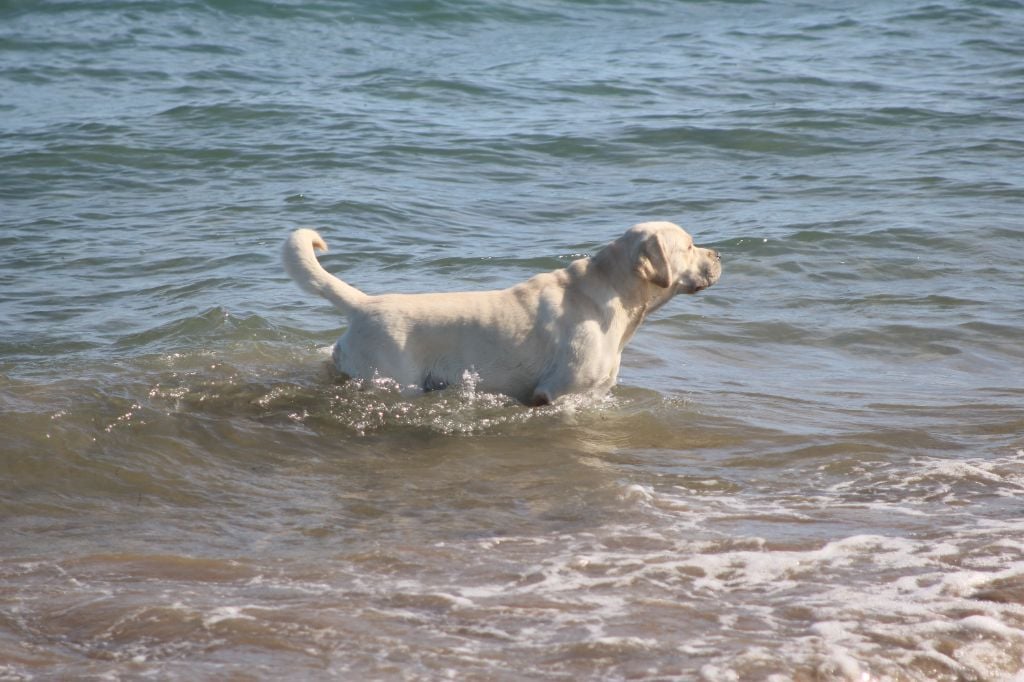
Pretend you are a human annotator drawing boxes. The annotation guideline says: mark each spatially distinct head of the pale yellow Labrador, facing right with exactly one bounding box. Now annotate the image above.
[622,222,722,297]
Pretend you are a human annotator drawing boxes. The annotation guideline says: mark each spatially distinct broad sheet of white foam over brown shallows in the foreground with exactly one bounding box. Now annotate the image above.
[28,440,1011,682]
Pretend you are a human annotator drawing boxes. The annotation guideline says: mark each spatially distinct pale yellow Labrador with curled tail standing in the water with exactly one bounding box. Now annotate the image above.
[283,222,722,407]
